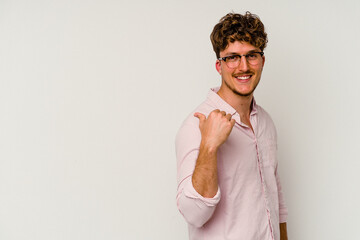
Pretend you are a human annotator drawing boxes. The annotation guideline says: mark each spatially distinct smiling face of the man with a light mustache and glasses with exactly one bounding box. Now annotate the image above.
[216,41,265,98]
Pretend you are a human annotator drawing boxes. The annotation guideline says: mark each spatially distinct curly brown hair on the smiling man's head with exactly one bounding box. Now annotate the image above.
[210,12,268,58]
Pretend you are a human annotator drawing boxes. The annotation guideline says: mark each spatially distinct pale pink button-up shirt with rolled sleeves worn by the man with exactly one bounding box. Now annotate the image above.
[176,88,287,240]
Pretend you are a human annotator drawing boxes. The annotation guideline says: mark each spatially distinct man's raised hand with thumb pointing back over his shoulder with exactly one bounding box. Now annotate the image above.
[194,109,235,149]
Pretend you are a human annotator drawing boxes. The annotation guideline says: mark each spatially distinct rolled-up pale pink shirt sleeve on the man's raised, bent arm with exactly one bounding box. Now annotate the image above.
[175,123,220,227]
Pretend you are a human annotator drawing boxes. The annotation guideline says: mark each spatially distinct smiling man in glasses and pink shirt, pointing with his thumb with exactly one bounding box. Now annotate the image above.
[176,12,287,240]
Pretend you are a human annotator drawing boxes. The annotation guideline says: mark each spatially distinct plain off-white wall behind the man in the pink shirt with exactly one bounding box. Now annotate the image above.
[0,0,360,240]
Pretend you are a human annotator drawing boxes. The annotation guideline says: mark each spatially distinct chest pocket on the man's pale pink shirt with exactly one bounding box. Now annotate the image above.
[260,139,277,170]
